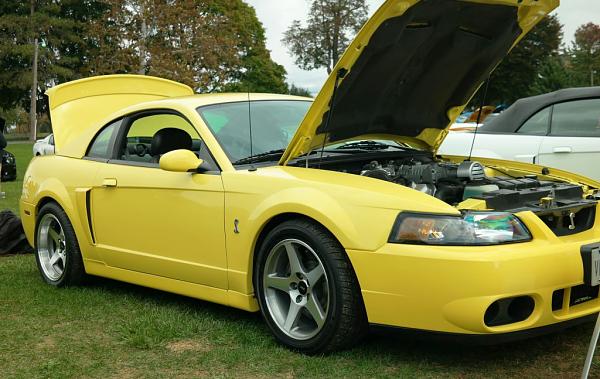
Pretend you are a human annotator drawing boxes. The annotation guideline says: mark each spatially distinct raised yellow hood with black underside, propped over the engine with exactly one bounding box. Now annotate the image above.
[280,0,559,164]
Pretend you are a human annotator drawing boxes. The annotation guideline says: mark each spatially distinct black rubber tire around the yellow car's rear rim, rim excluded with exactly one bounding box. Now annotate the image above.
[35,203,86,287]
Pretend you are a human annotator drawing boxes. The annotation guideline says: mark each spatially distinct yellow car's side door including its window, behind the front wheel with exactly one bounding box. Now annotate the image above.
[91,111,227,289]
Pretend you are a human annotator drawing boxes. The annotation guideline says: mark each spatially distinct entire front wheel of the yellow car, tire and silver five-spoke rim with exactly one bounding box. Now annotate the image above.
[254,219,367,354]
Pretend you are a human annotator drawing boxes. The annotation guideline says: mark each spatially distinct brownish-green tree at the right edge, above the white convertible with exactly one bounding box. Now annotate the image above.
[569,22,600,86]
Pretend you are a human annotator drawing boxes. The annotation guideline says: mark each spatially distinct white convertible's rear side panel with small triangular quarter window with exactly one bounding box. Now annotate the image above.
[439,108,550,163]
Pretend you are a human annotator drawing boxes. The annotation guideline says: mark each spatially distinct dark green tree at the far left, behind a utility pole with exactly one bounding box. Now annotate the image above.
[0,0,106,138]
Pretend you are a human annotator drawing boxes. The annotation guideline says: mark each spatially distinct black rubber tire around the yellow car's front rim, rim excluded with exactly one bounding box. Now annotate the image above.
[254,219,368,355]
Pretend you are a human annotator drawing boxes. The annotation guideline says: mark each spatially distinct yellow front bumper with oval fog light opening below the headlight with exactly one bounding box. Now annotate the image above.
[348,208,600,335]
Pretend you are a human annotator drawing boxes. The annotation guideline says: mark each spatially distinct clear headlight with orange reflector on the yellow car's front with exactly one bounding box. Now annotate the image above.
[389,212,531,246]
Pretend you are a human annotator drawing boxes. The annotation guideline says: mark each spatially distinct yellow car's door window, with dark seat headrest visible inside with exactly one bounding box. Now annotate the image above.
[119,113,202,164]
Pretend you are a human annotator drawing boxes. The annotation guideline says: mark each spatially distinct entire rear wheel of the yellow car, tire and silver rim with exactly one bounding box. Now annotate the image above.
[35,203,85,287]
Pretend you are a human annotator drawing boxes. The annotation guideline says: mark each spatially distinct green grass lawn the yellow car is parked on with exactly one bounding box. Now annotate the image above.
[0,145,600,378]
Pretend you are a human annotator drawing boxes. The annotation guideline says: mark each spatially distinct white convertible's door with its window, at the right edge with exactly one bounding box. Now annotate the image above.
[539,99,600,180]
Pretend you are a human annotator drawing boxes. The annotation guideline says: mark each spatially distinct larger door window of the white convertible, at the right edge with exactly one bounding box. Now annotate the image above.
[551,99,600,137]
